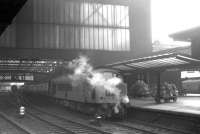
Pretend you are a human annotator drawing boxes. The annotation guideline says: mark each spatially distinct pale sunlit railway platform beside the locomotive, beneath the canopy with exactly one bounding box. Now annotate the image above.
[130,96,200,117]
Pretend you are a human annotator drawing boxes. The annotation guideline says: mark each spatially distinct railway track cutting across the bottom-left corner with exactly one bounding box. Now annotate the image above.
[0,112,33,134]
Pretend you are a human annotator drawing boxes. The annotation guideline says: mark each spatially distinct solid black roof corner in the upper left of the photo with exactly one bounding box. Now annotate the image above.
[0,0,27,35]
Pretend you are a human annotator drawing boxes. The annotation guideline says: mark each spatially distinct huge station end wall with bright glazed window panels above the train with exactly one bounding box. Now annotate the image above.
[0,0,152,66]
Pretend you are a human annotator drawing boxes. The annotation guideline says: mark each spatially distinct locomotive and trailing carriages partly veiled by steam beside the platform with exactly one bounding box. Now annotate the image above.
[22,70,129,118]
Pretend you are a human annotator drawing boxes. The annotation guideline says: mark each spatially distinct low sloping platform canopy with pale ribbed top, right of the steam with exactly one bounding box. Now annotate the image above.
[100,53,200,73]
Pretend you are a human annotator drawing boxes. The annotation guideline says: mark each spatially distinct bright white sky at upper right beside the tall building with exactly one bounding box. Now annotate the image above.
[151,0,200,46]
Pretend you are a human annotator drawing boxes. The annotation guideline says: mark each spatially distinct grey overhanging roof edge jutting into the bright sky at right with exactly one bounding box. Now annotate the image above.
[169,26,200,41]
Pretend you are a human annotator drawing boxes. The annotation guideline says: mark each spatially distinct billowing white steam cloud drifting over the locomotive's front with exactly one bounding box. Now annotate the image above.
[68,56,127,113]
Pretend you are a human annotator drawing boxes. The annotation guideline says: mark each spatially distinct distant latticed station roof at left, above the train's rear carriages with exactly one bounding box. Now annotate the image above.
[0,59,64,73]
